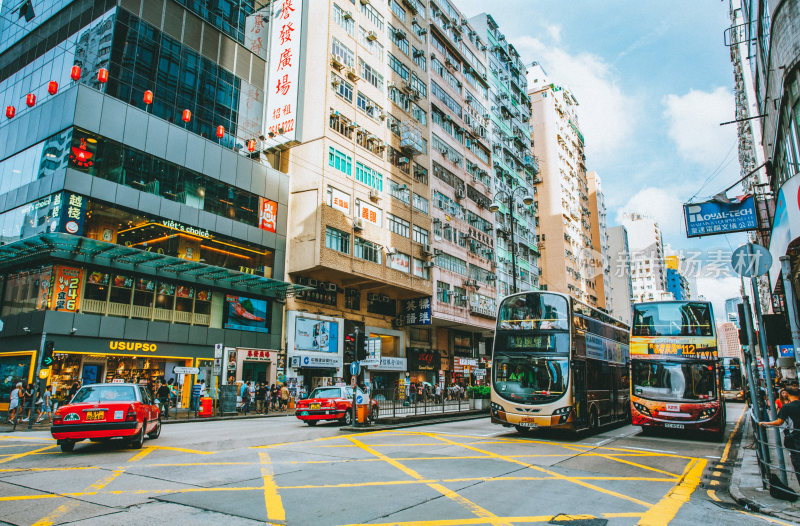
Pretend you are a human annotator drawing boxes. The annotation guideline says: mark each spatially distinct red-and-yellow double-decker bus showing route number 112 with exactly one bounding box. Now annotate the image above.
[630,301,725,437]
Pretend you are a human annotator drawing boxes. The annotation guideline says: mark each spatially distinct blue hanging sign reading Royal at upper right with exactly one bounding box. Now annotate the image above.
[683,195,758,237]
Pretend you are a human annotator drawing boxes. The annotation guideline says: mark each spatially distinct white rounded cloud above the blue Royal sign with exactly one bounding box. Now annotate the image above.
[662,87,736,166]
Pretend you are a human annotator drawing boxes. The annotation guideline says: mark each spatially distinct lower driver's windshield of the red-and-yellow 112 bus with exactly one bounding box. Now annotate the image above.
[631,360,717,402]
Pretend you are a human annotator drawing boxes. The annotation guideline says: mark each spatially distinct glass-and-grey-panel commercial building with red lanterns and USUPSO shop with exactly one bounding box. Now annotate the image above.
[0,0,293,403]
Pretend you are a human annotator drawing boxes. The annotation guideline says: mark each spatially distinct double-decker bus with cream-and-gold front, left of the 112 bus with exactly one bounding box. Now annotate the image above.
[491,291,630,433]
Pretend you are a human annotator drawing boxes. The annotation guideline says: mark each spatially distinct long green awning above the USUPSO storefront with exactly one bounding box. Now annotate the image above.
[0,233,311,299]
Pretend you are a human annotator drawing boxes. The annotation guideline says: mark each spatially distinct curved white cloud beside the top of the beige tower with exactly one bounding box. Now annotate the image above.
[513,35,641,163]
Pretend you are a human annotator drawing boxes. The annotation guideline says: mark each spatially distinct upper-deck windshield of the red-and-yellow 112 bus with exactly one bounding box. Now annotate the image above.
[631,302,714,336]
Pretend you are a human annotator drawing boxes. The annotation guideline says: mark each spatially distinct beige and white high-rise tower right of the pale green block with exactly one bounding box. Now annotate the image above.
[528,64,599,305]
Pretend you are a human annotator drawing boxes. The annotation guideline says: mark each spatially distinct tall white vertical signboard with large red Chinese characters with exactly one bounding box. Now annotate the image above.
[266,0,303,146]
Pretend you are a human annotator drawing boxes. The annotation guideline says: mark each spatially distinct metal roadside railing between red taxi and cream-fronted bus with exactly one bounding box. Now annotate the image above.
[370,389,478,418]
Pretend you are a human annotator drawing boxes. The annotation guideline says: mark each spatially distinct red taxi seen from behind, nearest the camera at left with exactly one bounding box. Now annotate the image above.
[50,383,161,452]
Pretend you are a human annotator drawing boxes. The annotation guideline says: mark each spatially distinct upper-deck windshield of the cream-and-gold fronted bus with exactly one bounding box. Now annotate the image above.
[497,292,569,331]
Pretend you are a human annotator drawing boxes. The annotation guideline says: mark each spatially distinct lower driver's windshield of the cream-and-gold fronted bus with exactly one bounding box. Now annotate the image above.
[492,351,569,404]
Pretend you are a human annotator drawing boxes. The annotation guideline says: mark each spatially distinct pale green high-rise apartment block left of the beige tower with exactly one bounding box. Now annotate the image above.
[468,13,539,297]
